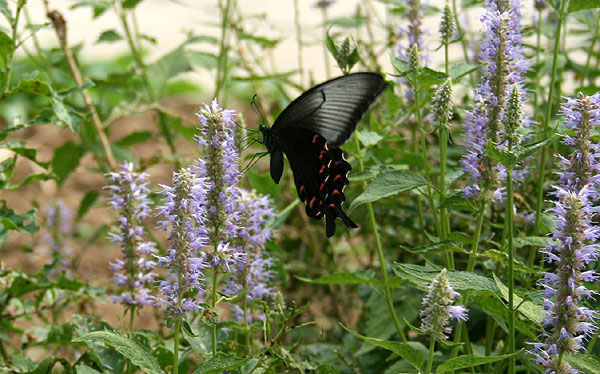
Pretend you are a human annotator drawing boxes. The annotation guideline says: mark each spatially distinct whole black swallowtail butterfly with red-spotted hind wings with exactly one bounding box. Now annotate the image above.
[260,73,386,237]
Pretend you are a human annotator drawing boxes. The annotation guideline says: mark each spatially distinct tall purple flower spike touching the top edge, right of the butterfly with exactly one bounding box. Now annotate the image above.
[461,0,529,200]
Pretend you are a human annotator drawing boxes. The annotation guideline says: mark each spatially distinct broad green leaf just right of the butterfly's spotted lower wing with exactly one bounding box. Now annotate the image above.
[348,171,427,212]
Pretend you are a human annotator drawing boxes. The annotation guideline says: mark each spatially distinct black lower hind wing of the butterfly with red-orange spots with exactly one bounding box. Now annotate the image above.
[278,128,358,237]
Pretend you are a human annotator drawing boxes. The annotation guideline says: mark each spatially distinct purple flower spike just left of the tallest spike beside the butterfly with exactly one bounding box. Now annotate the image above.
[158,169,209,318]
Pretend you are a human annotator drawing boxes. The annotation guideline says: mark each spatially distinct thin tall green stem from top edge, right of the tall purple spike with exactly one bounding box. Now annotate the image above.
[529,0,569,240]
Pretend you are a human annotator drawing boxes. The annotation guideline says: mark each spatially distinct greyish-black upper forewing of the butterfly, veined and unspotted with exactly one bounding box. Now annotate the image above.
[271,73,386,147]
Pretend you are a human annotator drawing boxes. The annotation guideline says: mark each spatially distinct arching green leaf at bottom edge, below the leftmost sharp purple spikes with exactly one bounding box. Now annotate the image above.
[74,330,163,374]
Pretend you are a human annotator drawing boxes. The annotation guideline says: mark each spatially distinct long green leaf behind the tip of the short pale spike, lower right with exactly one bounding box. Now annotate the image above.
[393,263,499,294]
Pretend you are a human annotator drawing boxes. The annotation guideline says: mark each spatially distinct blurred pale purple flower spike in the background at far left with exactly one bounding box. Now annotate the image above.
[43,200,73,276]
